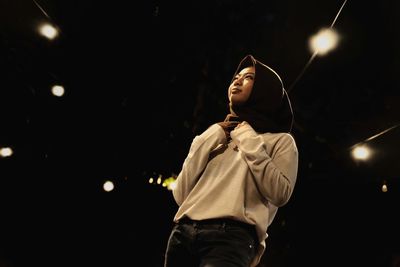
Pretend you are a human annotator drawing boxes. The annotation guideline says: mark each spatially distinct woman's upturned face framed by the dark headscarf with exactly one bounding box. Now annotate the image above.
[228,67,255,106]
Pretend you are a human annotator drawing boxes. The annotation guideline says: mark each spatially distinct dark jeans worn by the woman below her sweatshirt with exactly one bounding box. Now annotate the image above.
[164,220,258,267]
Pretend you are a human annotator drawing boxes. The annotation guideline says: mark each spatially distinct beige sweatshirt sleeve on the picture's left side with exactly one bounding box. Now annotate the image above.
[172,124,226,206]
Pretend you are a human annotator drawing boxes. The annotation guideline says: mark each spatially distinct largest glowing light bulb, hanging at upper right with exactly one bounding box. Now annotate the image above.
[309,28,339,55]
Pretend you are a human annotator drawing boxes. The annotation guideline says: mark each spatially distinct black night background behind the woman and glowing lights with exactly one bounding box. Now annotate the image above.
[0,0,400,267]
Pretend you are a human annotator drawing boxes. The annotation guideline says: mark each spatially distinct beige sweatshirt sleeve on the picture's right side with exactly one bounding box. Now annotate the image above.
[231,123,298,207]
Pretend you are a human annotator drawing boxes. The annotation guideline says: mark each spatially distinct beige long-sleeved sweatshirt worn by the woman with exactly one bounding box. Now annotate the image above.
[173,123,298,266]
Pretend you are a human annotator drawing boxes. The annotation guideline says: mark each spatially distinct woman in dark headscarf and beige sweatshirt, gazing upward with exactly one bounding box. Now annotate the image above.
[164,55,298,267]
